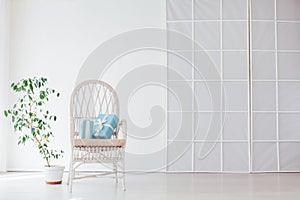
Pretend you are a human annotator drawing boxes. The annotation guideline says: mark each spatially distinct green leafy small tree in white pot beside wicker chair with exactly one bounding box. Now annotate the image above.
[4,77,64,184]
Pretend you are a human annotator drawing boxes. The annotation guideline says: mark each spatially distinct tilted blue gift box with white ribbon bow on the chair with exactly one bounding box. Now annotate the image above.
[93,114,119,139]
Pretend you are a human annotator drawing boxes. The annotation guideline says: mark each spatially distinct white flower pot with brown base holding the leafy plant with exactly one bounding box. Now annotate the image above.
[44,165,65,184]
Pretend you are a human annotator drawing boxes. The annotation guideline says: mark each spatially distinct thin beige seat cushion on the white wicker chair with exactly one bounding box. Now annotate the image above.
[74,139,126,147]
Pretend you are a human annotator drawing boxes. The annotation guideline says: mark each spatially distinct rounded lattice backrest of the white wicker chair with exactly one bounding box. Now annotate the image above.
[70,80,119,138]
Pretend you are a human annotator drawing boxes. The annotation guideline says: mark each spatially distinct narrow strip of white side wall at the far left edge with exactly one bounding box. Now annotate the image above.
[0,0,10,171]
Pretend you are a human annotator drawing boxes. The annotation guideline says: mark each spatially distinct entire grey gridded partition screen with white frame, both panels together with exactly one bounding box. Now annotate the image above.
[167,0,300,172]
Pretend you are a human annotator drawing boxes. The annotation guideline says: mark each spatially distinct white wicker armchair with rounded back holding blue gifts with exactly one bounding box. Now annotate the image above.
[68,80,127,192]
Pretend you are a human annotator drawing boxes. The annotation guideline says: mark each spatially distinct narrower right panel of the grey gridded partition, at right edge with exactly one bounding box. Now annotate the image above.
[251,0,300,171]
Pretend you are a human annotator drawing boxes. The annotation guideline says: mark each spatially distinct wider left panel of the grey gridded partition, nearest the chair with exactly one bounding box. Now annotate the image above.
[167,0,250,172]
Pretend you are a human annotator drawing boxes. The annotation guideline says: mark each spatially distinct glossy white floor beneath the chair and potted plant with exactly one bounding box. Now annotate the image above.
[0,173,300,200]
